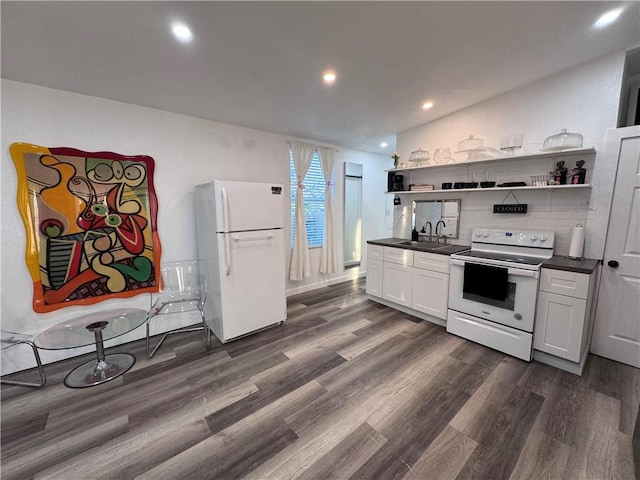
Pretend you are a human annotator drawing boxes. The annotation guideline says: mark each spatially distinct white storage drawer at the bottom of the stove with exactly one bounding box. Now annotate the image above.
[447,310,533,362]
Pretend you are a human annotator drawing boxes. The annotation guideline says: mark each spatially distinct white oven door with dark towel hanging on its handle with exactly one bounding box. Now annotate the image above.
[449,259,540,332]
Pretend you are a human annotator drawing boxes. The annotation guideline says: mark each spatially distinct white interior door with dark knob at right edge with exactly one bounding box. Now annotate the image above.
[591,127,640,367]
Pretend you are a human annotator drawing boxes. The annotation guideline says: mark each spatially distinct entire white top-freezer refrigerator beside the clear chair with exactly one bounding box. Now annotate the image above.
[195,180,287,343]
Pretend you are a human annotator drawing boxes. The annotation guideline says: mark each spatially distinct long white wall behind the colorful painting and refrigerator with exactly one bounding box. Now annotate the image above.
[0,80,391,374]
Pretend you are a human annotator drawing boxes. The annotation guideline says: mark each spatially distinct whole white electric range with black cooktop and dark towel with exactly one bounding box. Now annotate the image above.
[447,228,554,361]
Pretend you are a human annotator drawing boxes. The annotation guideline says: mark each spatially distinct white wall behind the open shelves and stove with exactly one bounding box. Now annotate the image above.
[394,52,625,258]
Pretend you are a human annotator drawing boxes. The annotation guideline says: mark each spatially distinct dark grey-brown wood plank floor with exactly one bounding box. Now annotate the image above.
[1,281,640,480]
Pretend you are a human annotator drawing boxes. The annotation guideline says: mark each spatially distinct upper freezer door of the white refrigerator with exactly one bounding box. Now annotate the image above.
[214,180,287,232]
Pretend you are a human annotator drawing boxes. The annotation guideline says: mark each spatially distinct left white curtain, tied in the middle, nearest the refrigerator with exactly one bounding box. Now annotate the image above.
[289,141,316,281]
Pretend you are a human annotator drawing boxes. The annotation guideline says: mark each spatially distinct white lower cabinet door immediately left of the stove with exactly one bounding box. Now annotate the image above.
[411,268,449,320]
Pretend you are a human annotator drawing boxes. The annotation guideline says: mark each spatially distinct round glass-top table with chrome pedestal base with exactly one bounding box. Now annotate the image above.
[34,308,147,388]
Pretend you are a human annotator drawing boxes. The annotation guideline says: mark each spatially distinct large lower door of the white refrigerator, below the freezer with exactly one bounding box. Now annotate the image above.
[218,229,287,343]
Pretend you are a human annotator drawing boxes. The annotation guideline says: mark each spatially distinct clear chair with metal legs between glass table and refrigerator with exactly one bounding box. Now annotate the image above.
[146,260,211,358]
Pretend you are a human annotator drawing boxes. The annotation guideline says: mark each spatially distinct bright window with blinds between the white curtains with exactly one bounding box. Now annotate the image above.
[289,151,333,247]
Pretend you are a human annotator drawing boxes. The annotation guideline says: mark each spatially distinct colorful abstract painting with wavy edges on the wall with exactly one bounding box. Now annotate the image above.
[11,143,160,313]
